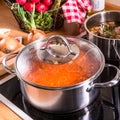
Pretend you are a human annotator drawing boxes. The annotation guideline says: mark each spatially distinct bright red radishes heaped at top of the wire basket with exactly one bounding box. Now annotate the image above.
[16,0,53,12]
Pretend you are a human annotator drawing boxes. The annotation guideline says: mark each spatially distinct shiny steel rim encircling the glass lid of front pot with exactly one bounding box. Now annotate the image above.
[14,36,105,90]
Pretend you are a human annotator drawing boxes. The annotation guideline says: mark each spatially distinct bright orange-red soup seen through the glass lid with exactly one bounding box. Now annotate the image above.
[24,51,100,87]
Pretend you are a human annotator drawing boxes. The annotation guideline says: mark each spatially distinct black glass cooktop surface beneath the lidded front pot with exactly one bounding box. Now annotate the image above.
[0,65,120,120]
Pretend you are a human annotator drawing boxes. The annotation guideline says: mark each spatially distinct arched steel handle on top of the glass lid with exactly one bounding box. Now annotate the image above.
[41,35,76,58]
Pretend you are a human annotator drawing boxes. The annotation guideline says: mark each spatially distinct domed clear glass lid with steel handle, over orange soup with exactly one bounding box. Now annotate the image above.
[16,35,104,87]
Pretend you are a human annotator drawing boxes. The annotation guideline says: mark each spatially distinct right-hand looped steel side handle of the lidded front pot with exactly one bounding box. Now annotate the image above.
[87,64,120,92]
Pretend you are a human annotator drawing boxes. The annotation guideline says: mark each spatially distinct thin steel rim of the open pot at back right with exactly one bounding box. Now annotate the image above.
[84,10,120,40]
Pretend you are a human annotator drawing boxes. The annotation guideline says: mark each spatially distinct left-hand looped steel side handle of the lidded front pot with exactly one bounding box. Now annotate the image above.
[2,52,18,74]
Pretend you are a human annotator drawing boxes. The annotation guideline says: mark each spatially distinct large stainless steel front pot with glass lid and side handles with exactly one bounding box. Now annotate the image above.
[2,35,120,114]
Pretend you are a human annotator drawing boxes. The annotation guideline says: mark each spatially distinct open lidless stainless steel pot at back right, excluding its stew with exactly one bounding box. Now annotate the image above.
[84,10,120,62]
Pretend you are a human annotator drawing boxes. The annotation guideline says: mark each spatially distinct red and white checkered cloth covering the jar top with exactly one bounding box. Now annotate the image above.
[62,0,92,24]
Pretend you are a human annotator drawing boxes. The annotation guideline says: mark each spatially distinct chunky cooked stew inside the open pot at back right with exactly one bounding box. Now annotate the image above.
[89,21,120,39]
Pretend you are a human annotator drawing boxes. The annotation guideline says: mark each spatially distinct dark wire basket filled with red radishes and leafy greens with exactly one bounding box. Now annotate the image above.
[11,0,66,32]
